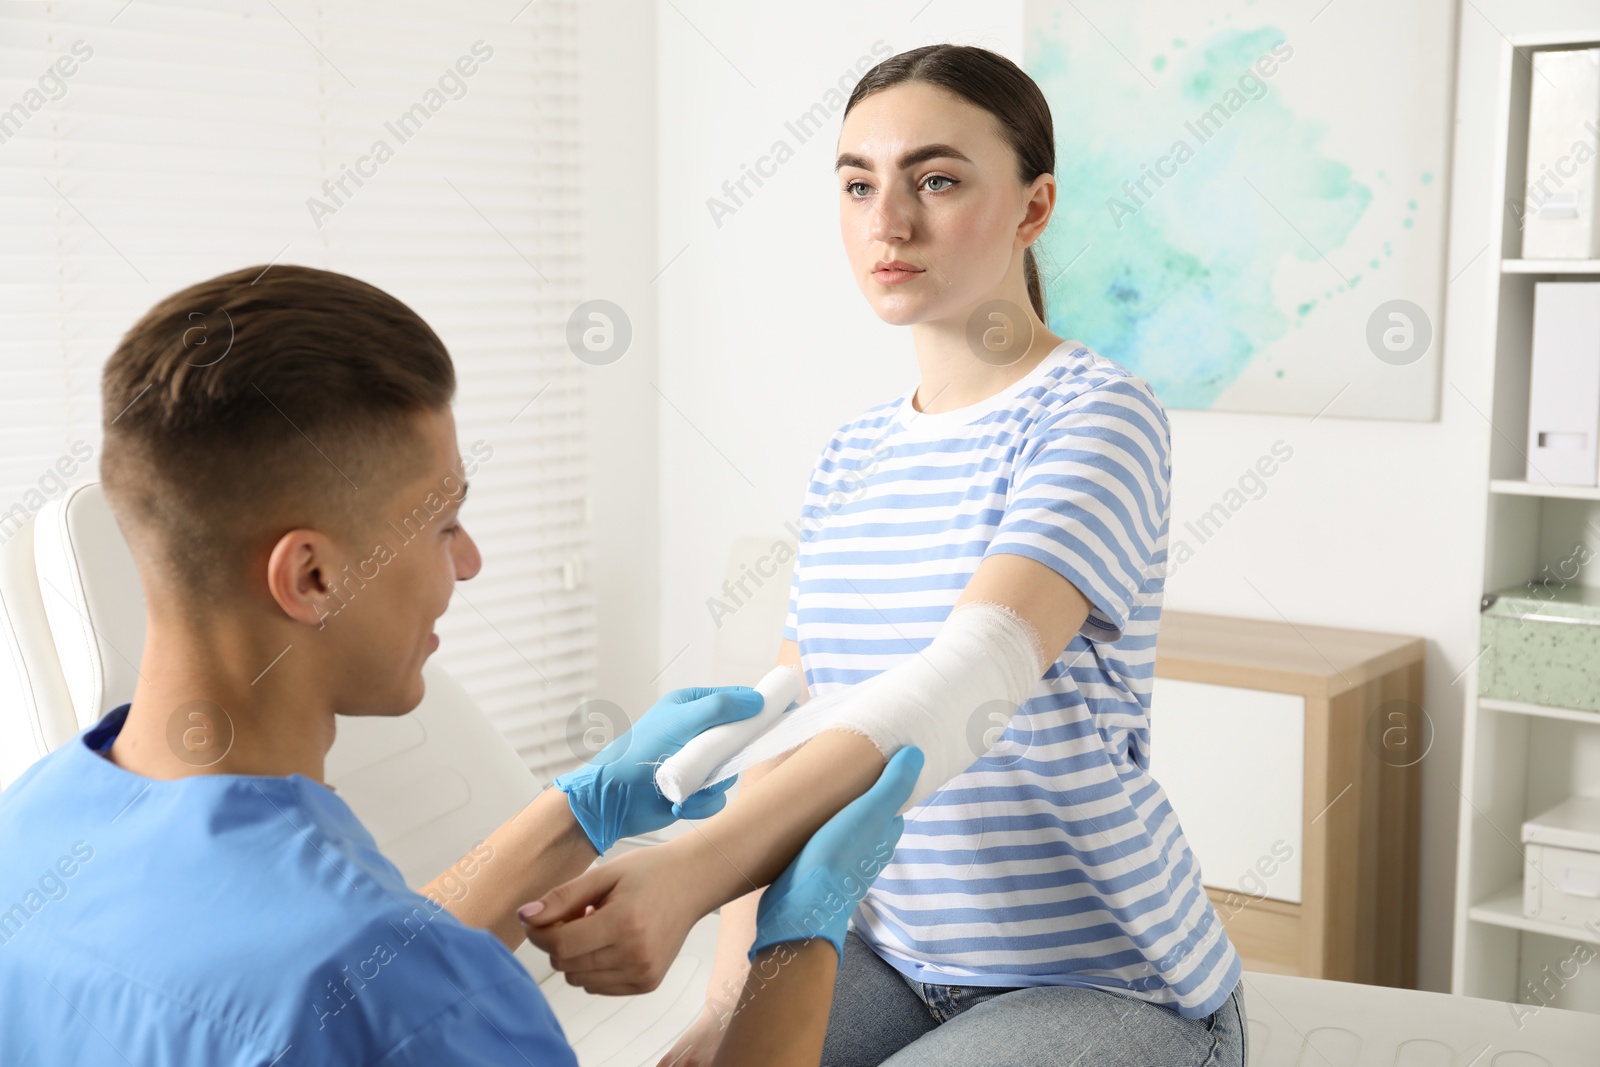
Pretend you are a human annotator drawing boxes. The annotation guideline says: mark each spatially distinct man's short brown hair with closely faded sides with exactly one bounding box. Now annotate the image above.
[101,266,456,598]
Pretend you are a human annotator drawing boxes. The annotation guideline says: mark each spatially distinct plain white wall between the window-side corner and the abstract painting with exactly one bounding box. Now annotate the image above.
[656,0,1022,685]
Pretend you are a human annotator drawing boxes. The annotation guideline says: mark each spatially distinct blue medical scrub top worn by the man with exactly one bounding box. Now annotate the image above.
[0,704,578,1067]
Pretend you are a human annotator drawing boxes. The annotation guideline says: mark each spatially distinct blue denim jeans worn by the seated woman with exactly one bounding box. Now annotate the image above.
[822,931,1248,1067]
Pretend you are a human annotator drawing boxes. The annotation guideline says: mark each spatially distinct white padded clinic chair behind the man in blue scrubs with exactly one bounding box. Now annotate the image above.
[0,483,717,1067]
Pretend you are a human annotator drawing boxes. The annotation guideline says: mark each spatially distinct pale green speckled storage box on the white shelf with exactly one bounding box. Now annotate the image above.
[1478,582,1600,712]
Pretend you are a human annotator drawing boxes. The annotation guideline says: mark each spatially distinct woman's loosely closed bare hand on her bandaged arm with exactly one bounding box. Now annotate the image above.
[517,833,720,997]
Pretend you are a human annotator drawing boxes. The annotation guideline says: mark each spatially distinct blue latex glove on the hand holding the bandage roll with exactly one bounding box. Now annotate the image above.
[552,685,762,854]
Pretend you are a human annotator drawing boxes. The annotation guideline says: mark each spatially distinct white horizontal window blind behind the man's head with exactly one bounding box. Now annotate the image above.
[0,0,595,777]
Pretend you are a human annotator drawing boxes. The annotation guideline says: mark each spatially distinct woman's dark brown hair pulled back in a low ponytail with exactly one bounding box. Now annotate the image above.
[840,45,1056,322]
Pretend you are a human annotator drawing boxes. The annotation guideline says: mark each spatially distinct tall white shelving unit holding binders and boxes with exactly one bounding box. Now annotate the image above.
[1451,35,1600,1013]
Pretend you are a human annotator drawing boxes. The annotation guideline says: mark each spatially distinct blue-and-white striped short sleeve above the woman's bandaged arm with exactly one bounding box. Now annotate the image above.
[984,376,1171,641]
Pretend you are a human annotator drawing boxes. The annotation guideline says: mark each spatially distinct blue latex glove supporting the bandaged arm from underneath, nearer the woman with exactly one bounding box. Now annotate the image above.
[750,745,923,961]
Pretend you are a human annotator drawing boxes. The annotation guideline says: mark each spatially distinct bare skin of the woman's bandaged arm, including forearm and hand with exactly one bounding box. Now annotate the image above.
[528,553,1090,993]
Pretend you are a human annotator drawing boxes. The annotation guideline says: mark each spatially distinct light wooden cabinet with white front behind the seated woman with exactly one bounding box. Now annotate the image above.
[1150,611,1434,987]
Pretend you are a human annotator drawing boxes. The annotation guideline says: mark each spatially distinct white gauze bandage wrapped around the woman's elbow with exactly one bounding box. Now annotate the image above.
[706,601,1053,811]
